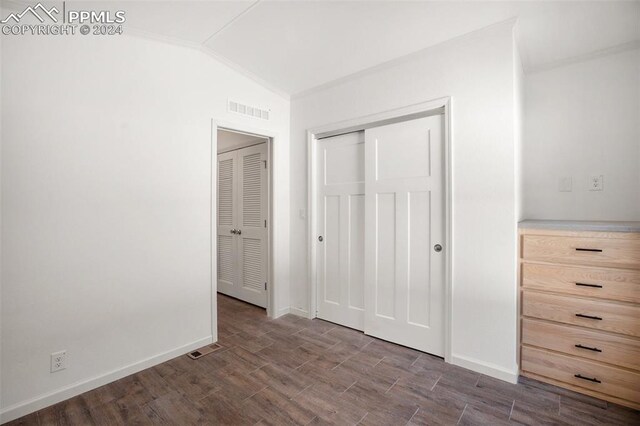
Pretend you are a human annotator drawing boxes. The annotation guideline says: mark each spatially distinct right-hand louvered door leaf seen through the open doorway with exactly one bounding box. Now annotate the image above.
[236,143,267,308]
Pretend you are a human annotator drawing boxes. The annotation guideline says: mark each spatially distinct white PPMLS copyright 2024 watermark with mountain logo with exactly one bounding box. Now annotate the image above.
[0,1,126,36]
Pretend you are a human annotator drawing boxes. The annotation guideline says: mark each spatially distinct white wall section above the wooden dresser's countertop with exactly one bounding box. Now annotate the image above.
[524,49,640,220]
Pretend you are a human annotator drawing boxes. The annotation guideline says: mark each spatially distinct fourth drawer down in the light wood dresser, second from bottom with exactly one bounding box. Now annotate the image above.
[522,318,640,370]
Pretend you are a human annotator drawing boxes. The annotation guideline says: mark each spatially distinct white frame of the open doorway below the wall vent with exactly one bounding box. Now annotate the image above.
[210,118,279,336]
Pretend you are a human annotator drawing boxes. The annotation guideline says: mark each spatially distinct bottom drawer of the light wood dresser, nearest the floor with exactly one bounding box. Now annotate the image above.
[522,346,640,403]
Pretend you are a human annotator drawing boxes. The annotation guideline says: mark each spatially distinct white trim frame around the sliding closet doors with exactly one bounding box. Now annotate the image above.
[307,96,453,362]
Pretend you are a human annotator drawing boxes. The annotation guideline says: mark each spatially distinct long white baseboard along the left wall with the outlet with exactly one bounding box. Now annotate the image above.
[0,336,213,423]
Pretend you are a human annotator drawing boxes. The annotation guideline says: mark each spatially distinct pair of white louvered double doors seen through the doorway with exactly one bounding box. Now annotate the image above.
[218,143,268,307]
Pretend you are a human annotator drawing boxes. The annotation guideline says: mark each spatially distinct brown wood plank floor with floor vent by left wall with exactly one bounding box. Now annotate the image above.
[10,295,640,425]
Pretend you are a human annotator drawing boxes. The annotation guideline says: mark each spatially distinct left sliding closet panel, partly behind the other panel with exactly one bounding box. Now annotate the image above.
[317,132,365,330]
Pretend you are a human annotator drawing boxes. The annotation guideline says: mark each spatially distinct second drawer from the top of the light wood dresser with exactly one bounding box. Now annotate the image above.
[522,263,640,303]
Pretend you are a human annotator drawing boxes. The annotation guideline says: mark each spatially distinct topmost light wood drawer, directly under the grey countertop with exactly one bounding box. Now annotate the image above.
[522,235,640,269]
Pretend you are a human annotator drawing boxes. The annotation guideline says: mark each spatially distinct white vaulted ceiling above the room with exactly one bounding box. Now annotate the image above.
[5,0,640,95]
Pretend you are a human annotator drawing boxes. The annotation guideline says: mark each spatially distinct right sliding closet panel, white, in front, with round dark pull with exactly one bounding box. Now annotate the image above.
[365,115,446,356]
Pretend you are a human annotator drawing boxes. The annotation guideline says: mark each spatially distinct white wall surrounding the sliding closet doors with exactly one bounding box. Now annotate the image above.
[291,22,518,380]
